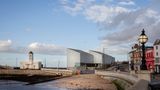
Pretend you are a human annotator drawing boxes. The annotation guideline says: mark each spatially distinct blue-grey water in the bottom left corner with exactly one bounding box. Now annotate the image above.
[0,80,67,90]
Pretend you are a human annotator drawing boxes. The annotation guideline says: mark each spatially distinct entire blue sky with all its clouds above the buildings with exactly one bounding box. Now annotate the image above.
[0,0,160,67]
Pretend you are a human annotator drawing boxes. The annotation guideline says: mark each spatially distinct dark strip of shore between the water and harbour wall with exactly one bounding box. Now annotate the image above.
[0,74,65,85]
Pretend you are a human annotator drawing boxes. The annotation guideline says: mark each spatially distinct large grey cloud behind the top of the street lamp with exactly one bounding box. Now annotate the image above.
[101,8,160,54]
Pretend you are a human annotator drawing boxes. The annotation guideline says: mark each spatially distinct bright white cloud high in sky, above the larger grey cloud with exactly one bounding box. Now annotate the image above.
[84,5,129,23]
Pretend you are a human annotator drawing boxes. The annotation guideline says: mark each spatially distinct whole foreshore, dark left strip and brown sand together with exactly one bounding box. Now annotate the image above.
[0,74,117,90]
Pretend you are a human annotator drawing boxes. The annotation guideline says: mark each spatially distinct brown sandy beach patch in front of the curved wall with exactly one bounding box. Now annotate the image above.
[49,74,117,90]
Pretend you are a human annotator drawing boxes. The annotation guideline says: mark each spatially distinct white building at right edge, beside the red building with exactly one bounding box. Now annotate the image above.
[154,39,160,73]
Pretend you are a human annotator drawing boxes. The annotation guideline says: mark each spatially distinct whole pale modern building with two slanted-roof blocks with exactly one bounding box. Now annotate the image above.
[67,48,115,69]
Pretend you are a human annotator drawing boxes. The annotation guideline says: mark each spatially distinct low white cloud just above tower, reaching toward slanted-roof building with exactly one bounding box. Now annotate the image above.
[28,42,66,55]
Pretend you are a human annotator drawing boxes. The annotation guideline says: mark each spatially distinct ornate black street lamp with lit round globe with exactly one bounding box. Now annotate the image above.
[138,29,148,70]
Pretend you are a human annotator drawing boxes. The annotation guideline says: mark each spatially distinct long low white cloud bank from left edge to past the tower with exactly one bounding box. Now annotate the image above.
[0,40,66,55]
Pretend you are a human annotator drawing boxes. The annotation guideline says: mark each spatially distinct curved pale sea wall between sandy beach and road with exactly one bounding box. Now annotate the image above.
[95,70,148,90]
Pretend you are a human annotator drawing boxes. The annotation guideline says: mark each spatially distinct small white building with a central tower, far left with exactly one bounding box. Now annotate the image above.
[20,51,42,69]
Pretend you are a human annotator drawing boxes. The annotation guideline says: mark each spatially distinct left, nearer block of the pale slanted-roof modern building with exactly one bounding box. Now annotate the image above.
[67,48,93,69]
